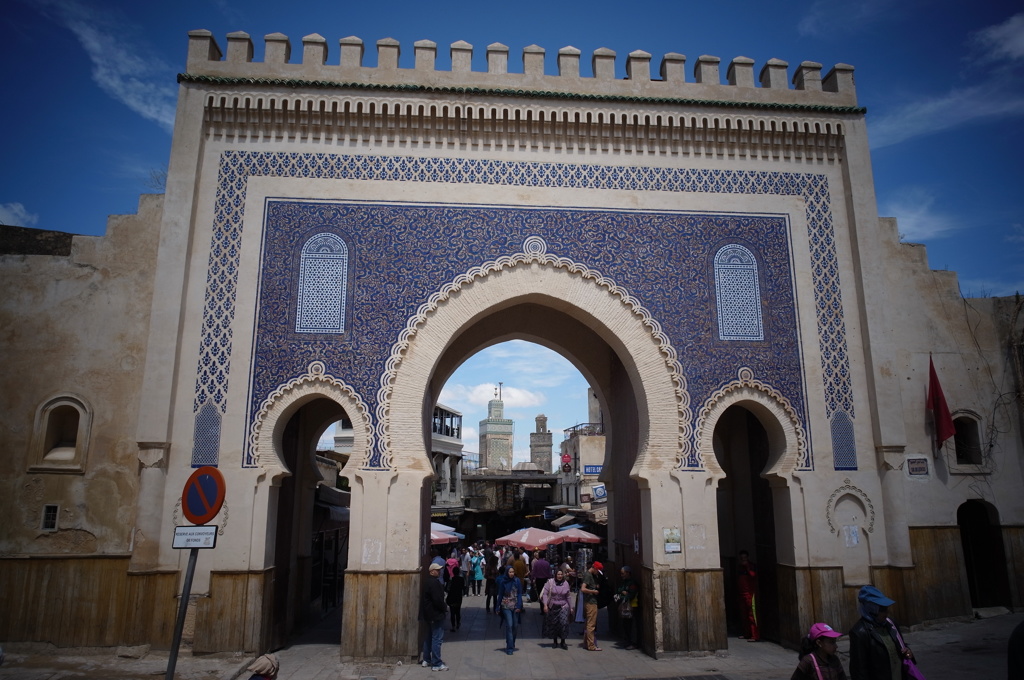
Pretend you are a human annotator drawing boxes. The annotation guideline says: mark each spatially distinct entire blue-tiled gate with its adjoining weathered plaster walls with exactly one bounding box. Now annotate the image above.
[0,31,1024,661]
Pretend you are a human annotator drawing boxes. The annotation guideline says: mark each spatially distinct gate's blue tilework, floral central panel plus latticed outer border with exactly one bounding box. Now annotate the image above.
[194,151,853,466]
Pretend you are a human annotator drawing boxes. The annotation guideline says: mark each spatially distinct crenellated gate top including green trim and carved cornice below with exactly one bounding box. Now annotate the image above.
[178,31,864,160]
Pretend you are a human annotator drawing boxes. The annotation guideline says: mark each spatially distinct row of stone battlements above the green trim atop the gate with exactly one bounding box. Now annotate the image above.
[183,31,857,109]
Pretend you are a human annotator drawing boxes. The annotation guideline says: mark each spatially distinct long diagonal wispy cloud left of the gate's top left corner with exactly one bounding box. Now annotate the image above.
[38,0,177,132]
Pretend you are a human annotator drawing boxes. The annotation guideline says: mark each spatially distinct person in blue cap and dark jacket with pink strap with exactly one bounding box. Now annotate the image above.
[850,586,913,680]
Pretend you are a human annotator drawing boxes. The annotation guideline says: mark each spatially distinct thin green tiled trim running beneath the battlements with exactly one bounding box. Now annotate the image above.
[178,73,867,114]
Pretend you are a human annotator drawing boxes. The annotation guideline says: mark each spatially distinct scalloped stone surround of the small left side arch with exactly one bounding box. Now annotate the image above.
[249,362,374,483]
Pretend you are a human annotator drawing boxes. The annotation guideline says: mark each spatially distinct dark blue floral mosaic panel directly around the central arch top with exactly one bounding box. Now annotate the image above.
[249,201,804,467]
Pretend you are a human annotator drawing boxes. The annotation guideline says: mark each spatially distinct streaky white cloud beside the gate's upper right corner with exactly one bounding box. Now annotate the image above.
[868,80,1024,148]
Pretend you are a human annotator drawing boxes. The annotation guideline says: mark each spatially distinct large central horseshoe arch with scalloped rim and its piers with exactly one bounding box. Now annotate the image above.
[342,241,724,657]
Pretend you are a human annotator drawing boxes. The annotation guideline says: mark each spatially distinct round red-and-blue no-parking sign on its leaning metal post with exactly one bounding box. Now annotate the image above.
[164,466,225,680]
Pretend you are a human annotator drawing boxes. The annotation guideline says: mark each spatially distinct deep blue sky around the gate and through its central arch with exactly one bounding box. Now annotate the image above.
[0,0,1024,462]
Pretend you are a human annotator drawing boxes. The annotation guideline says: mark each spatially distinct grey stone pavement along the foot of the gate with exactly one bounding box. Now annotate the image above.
[0,596,1024,680]
